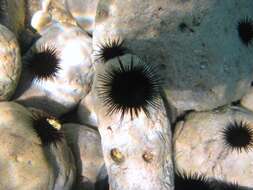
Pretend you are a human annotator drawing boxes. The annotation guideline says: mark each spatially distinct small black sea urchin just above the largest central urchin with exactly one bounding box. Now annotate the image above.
[96,38,128,62]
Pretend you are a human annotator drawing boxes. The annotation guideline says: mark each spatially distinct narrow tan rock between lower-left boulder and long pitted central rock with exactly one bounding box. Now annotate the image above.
[63,124,104,190]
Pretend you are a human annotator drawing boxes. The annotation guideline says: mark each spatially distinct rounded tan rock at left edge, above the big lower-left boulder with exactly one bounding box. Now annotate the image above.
[0,25,22,101]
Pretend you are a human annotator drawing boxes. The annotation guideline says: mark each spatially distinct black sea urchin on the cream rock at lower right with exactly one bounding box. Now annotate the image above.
[222,121,253,152]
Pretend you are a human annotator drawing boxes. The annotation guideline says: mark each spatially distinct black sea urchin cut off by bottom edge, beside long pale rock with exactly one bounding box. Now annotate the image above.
[175,172,213,190]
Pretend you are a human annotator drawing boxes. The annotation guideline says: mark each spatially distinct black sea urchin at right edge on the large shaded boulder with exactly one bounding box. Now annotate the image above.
[237,17,253,46]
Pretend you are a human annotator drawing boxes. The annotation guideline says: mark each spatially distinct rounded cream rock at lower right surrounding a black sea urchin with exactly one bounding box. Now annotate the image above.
[173,107,253,187]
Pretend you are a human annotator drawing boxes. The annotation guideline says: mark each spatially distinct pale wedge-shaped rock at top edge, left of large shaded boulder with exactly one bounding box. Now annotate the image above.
[65,0,99,33]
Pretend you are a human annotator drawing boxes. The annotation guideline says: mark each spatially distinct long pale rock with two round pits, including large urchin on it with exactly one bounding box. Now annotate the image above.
[92,54,174,190]
